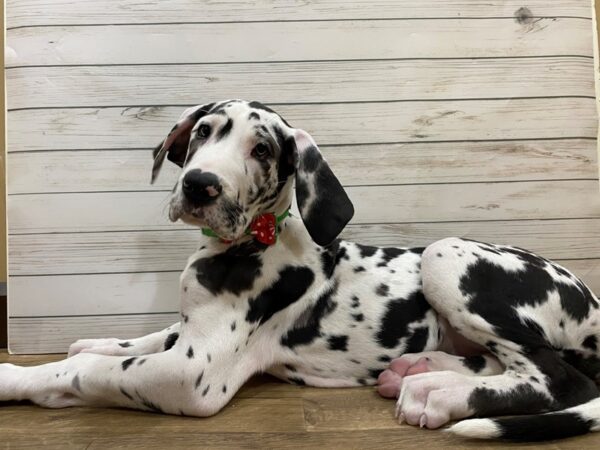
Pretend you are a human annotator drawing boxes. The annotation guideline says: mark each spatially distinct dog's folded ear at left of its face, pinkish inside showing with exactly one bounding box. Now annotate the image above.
[150,103,214,183]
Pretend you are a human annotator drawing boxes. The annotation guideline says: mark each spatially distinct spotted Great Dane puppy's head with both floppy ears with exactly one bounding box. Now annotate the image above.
[152,100,354,245]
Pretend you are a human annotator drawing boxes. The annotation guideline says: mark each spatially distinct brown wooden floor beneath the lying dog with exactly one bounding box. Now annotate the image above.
[0,352,600,450]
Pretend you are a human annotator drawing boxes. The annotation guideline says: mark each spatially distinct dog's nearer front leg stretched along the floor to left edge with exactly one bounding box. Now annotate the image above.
[0,341,251,416]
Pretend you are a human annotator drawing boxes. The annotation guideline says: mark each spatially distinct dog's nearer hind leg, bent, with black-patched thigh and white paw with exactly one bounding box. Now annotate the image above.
[398,239,598,428]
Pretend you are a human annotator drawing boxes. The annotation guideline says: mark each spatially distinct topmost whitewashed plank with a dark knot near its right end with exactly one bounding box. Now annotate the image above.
[6,0,591,27]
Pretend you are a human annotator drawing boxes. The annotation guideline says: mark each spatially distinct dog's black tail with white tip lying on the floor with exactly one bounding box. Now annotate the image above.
[448,397,600,442]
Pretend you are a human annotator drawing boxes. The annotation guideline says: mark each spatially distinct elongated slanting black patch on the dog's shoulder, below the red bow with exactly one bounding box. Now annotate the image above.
[246,266,315,324]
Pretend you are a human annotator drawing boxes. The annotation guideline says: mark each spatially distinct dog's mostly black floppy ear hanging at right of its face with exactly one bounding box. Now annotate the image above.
[293,129,354,246]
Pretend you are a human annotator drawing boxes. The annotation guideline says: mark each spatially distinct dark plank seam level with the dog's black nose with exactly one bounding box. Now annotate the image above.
[8,177,598,197]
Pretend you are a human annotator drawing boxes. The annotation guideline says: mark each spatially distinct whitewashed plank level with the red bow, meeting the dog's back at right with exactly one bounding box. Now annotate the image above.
[9,219,600,278]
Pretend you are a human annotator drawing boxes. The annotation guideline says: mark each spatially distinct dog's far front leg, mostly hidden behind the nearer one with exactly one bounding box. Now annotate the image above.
[69,322,180,356]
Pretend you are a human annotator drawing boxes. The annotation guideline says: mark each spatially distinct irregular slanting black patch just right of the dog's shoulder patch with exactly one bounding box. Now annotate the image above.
[281,283,338,349]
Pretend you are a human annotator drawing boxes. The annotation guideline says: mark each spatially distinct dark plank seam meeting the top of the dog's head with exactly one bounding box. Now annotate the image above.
[7,95,596,113]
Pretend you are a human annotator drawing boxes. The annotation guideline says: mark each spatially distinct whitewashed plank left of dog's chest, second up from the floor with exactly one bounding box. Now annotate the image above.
[9,272,179,317]
